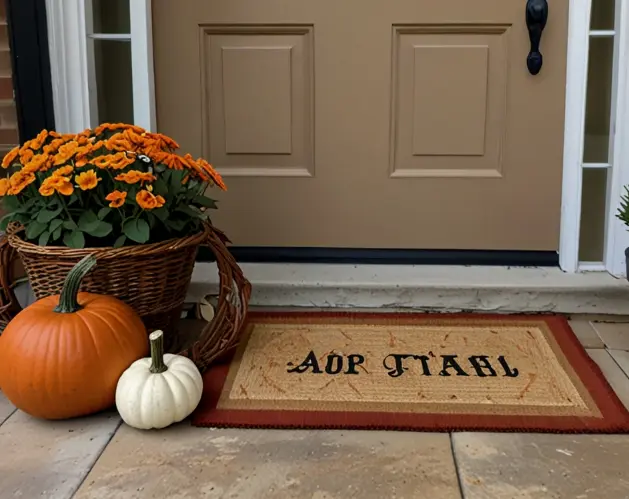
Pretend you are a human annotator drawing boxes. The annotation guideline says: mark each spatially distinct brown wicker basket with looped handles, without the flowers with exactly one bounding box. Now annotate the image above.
[0,224,251,371]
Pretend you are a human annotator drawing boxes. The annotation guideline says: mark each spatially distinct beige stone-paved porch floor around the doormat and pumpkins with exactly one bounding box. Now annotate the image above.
[0,316,629,499]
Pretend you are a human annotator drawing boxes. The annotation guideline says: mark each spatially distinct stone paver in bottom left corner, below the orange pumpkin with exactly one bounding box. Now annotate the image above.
[0,411,120,499]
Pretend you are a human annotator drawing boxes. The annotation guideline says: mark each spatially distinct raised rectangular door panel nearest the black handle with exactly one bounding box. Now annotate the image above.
[390,25,508,178]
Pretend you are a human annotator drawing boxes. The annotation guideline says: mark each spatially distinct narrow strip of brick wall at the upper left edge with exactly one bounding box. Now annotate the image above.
[0,0,19,157]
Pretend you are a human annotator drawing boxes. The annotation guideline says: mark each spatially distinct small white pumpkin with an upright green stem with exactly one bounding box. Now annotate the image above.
[116,331,203,430]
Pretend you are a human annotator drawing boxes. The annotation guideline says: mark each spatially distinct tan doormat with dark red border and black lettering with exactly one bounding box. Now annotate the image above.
[193,312,629,433]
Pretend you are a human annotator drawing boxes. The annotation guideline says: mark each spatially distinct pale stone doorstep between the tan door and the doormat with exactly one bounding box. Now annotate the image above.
[188,262,629,315]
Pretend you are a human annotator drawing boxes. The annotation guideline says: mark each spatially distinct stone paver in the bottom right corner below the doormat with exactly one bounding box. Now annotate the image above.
[452,433,629,499]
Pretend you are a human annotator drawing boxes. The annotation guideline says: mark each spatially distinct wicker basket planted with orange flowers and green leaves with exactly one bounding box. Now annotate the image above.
[0,124,250,376]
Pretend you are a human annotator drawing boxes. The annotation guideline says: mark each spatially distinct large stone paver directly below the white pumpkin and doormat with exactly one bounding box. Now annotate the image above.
[76,423,460,499]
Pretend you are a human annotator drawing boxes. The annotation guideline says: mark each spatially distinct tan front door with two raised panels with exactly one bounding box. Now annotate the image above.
[153,0,568,250]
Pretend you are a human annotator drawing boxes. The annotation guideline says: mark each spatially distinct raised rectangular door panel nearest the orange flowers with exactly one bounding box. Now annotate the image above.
[201,25,314,177]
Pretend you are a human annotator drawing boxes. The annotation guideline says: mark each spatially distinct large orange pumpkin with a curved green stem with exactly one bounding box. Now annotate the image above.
[0,256,148,419]
